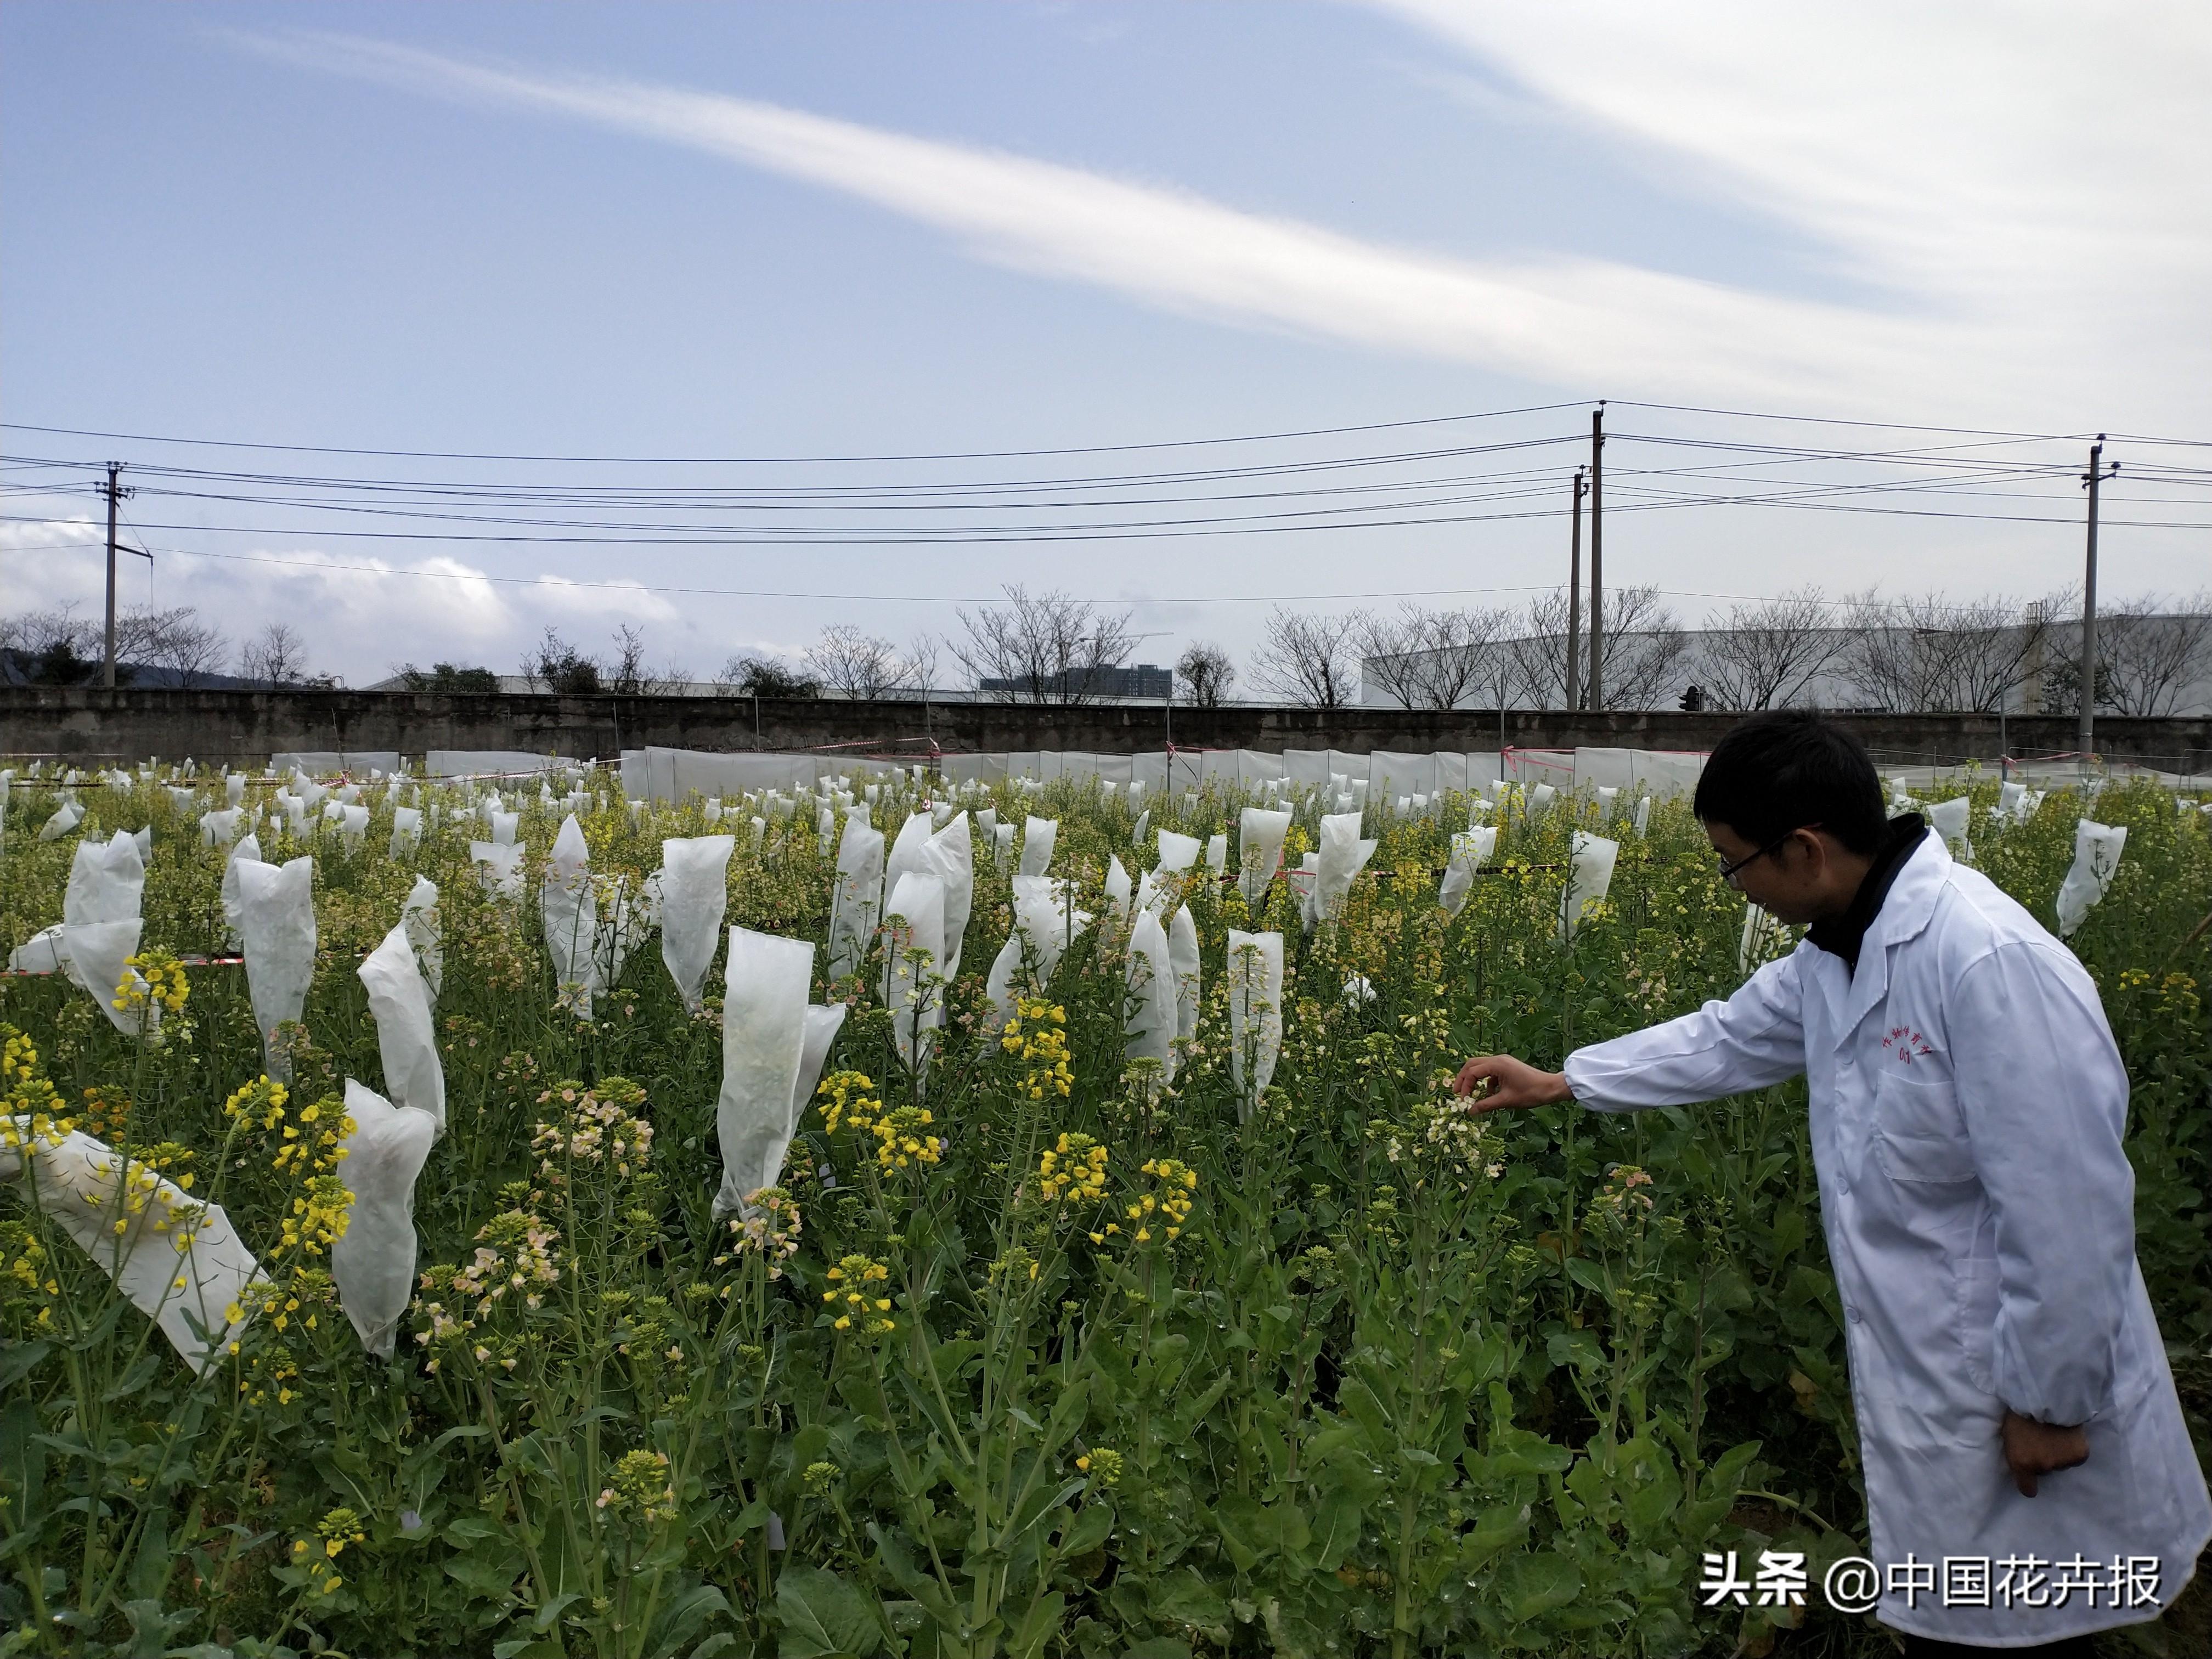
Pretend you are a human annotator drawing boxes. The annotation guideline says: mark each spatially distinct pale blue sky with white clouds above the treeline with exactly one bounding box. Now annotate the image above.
[0,0,2212,684]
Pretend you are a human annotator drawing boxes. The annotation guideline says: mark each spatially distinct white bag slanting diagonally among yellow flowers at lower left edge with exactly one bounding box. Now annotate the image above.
[0,1117,261,1372]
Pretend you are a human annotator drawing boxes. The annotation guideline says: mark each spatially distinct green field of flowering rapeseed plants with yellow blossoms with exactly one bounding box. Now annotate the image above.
[0,774,2212,1659]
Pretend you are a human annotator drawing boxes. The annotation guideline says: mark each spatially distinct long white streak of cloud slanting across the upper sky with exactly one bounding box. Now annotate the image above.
[229,29,2106,418]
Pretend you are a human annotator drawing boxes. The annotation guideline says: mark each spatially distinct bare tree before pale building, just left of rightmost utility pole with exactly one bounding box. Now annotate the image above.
[1841,589,2053,712]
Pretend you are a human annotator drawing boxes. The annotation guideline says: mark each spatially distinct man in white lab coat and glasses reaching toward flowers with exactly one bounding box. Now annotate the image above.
[1458,712,2212,1655]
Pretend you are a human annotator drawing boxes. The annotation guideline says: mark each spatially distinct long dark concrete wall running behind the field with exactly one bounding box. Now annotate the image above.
[0,686,2212,772]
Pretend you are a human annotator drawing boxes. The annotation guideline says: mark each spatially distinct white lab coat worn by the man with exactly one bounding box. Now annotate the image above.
[1566,832,2212,1648]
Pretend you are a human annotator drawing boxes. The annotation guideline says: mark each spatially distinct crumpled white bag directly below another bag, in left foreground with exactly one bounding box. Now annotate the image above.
[330,1079,438,1361]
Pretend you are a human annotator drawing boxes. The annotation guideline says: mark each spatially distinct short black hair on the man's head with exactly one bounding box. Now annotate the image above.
[1692,708,1889,854]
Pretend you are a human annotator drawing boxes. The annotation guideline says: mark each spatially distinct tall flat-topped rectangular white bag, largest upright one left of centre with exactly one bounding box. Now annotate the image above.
[714,927,814,1221]
